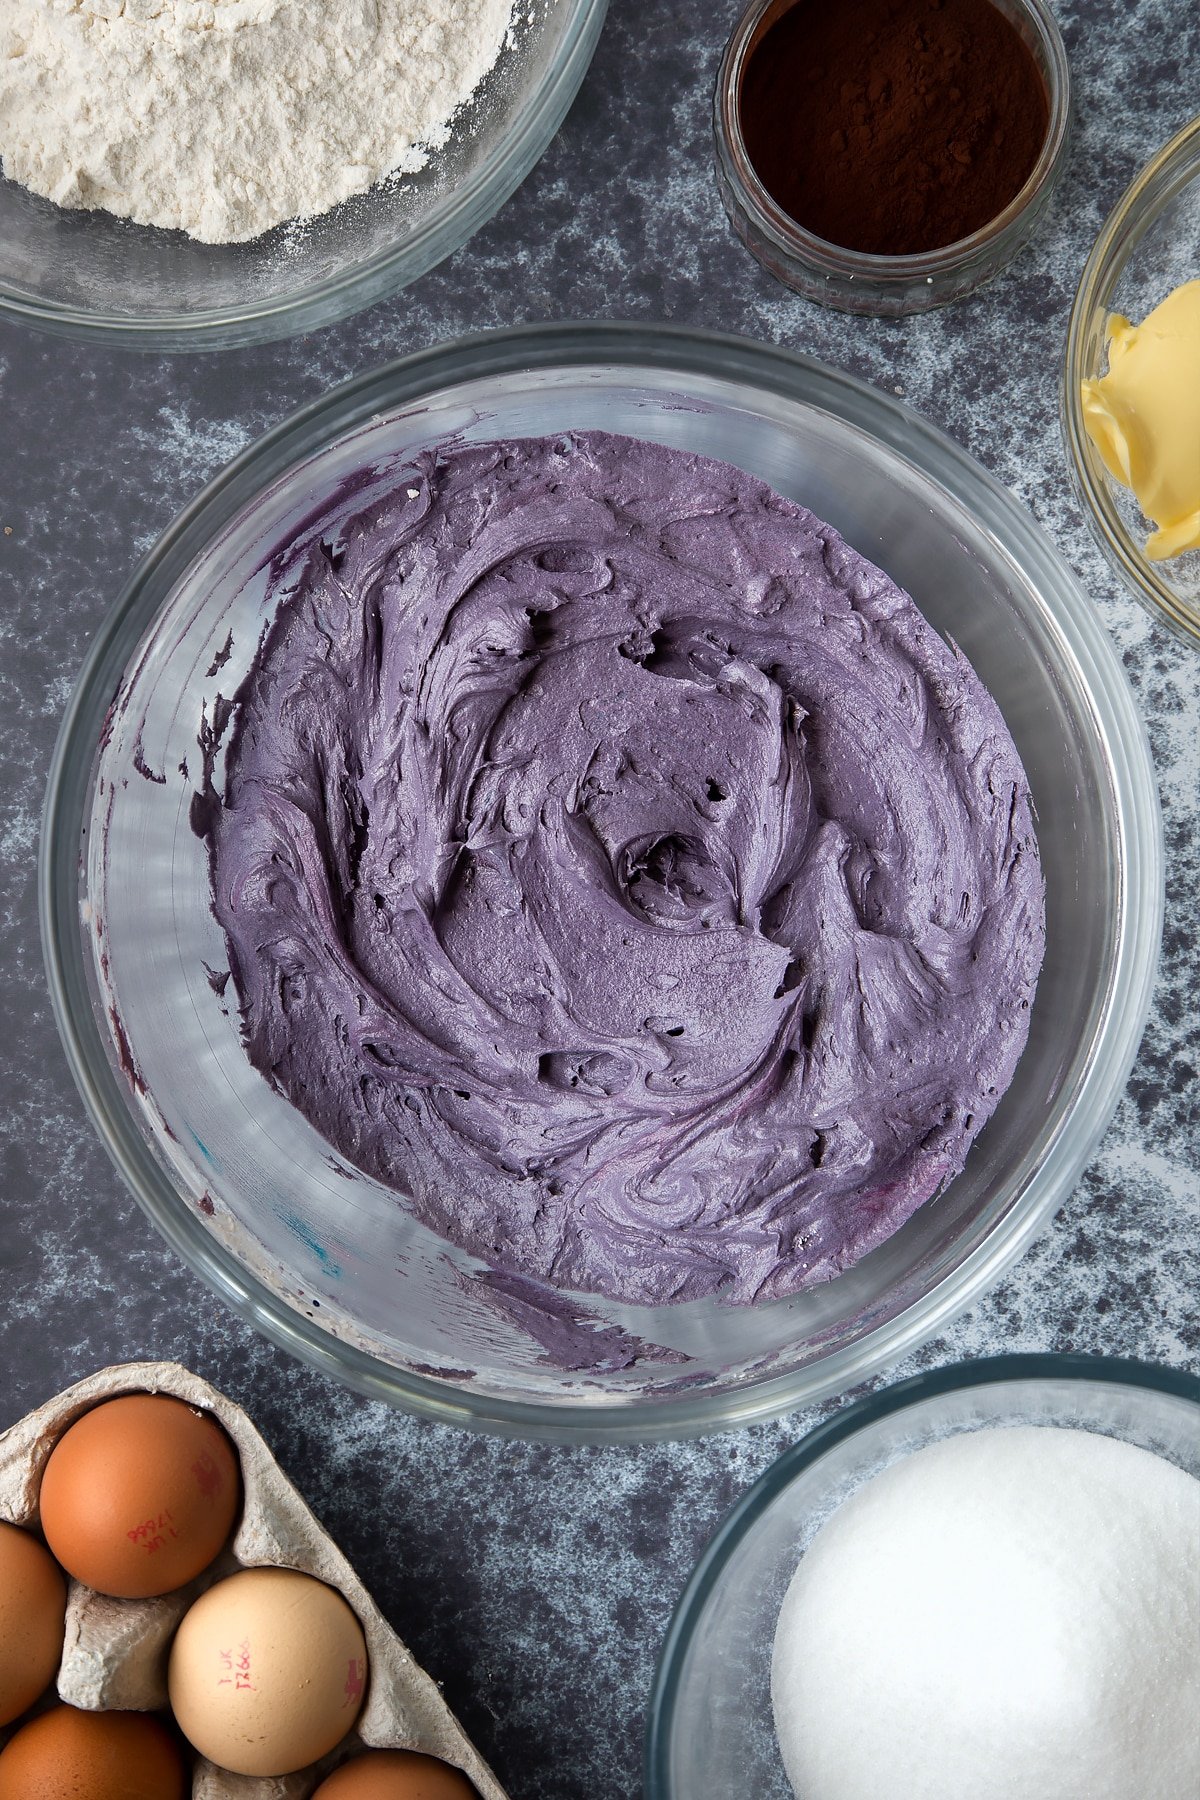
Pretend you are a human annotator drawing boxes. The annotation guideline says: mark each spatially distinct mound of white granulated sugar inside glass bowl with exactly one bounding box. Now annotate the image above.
[772,1427,1200,1800]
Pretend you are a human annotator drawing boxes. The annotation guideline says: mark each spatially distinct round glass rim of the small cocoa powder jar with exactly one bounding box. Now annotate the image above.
[712,0,1072,290]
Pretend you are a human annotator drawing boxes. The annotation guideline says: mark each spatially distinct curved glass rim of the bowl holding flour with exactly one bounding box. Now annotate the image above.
[0,0,608,351]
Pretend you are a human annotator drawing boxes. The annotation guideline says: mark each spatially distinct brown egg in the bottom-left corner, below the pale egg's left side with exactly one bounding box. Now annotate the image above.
[0,1706,191,1800]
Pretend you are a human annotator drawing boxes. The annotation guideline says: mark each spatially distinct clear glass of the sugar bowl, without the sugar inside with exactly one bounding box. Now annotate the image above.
[646,1355,1200,1800]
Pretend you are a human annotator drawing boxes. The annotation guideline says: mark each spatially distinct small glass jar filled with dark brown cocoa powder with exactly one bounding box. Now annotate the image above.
[714,0,1070,317]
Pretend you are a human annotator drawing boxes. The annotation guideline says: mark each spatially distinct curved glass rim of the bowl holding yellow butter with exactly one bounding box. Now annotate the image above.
[1060,113,1200,644]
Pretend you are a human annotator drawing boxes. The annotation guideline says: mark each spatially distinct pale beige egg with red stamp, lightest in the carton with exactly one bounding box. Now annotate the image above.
[167,1568,367,1775]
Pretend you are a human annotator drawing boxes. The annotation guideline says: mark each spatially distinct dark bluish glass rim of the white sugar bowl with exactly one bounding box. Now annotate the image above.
[644,1350,1200,1800]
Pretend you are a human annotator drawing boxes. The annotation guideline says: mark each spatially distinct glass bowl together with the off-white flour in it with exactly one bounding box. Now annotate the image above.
[0,0,606,351]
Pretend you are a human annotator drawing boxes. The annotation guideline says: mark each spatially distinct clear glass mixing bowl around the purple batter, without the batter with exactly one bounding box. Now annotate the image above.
[41,324,1162,1438]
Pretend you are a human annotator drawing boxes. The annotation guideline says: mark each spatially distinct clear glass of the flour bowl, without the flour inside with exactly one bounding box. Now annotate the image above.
[0,0,608,349]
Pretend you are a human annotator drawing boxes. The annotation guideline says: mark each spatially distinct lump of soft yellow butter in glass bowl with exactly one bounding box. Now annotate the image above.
[1083,281,1200,562]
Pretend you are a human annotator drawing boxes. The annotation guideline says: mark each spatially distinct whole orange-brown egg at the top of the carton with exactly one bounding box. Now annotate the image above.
[41,1393,241,1600]
